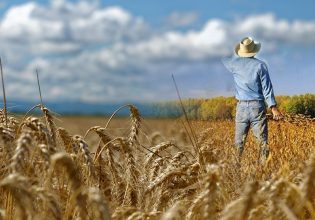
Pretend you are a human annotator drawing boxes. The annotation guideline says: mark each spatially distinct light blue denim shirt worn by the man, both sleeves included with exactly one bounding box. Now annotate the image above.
[222,56,277,107]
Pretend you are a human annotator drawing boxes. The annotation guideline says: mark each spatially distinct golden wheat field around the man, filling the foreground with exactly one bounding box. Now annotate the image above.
[0,105,315,220]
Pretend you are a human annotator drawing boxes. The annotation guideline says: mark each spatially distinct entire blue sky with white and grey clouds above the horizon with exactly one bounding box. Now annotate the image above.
[0,0,315,103]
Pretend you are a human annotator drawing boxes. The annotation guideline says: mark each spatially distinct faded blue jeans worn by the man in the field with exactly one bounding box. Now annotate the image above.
[235,100,269,158]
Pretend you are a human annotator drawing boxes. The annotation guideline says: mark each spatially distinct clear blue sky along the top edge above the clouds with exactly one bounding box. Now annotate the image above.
[1,0,314,22]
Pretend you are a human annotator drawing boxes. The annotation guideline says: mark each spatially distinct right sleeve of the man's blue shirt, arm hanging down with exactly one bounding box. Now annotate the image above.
[260,64,277,108]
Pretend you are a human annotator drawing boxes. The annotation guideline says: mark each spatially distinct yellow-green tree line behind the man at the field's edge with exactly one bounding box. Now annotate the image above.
[154,94,315,120]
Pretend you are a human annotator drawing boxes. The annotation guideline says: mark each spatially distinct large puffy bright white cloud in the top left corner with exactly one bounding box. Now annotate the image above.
[0,0,145,54]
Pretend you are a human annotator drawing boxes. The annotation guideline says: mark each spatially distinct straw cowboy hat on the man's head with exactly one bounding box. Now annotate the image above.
[235,37,261,57]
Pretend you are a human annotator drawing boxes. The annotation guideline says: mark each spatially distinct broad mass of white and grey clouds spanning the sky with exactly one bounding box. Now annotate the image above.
[0,0,315,101]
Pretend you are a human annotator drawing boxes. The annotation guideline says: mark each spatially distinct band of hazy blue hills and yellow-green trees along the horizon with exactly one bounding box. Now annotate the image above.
[4,94,315,120]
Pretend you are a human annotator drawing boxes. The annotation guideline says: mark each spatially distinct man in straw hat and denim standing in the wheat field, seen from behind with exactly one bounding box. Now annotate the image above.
[222,37,282,160]
